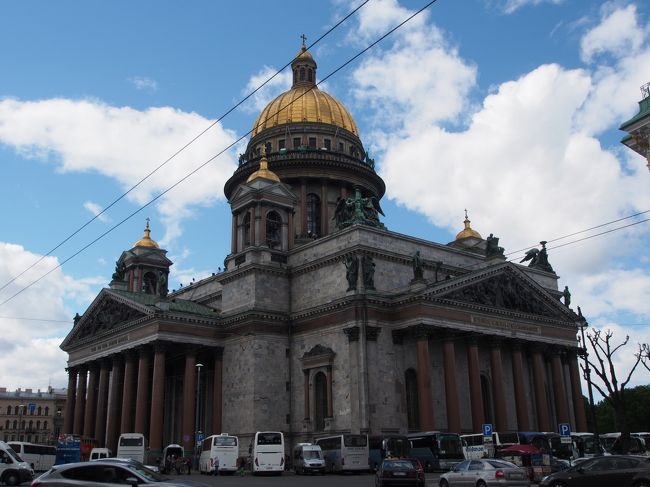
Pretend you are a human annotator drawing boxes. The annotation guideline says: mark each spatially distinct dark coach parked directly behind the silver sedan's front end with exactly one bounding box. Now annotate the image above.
[407,431,465,472]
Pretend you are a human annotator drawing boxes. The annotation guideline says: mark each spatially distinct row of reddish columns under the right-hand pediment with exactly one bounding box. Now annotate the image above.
[413,326,587,432]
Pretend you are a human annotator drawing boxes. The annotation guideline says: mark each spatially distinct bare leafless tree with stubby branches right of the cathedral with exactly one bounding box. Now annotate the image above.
[581,329,646,453]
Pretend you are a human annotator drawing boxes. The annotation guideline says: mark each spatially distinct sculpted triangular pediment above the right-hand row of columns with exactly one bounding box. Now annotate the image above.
[430,263,573,320]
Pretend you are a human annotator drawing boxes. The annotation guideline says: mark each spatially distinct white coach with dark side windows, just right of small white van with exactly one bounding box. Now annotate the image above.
[316,434,370,472]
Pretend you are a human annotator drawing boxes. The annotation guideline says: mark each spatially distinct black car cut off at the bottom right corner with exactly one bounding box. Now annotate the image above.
[539,455,650,487]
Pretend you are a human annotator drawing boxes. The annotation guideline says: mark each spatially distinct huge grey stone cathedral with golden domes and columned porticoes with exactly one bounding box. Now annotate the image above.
[61,45,587,458]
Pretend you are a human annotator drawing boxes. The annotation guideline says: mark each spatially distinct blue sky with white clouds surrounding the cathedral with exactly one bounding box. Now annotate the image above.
[0,0,650,400]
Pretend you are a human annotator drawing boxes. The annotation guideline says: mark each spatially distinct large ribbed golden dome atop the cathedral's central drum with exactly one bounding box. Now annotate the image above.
[251,86,359,137]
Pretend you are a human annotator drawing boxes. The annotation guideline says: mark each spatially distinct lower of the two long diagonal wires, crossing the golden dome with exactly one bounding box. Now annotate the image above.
[0,0,437,306]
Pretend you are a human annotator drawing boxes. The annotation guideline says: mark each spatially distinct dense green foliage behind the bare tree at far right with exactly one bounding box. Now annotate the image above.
[595,386,650,433]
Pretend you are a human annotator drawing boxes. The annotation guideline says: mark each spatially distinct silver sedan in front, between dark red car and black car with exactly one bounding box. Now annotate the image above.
[440,458,530,487]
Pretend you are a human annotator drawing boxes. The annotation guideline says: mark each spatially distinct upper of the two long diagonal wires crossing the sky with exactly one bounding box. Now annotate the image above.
[0,0,370,298]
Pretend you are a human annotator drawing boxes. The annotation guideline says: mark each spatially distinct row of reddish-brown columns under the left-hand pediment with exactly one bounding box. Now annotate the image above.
[63,342,223,455]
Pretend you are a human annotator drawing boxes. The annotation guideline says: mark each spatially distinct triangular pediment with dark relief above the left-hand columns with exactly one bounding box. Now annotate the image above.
[61,289,152,350]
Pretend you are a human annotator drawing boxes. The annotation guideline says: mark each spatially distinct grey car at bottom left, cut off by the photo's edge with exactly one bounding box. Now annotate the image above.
[31,459,207,487]
